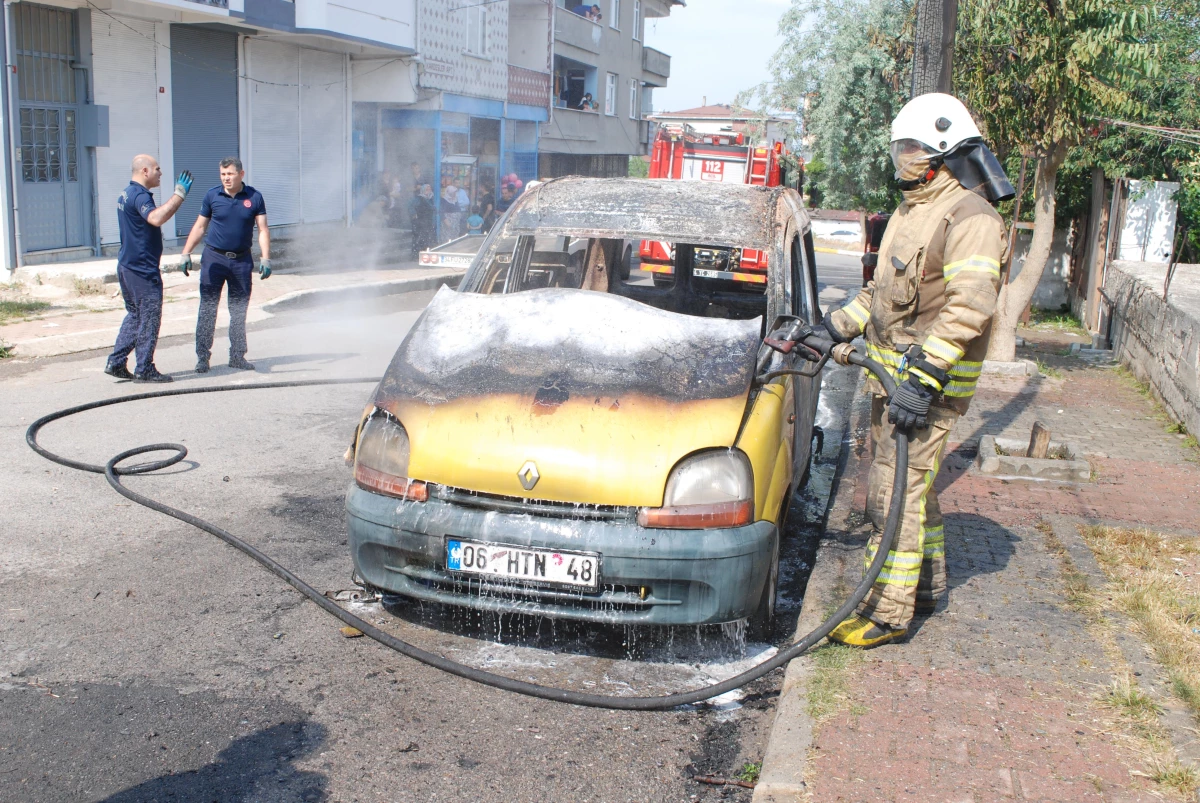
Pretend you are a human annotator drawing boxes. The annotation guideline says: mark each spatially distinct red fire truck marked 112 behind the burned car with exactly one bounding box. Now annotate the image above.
[638,124,804,287]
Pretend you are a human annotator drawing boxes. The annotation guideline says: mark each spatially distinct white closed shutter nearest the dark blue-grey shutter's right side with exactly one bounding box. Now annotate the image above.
[246,40,301,226]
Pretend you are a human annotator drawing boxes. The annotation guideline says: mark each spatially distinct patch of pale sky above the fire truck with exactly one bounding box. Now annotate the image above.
[646,0,790,112]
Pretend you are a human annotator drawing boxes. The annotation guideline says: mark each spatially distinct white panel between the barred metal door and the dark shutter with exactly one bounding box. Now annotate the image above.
[91,14,159,242]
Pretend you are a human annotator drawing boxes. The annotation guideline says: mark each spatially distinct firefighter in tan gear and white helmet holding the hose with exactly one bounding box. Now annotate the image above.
[822,94,1015,647]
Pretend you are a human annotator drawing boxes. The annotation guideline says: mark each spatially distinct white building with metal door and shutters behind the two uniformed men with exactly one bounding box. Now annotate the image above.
[0,0,418,270]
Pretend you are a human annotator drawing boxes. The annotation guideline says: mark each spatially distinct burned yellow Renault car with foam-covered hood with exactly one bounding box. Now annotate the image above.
[346,178,820,631]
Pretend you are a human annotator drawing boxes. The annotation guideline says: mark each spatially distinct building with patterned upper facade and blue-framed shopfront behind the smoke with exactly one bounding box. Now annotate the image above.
[354,0,554,235]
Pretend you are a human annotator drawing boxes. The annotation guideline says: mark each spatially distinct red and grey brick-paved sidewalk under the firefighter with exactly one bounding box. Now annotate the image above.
[755,328,1200,803]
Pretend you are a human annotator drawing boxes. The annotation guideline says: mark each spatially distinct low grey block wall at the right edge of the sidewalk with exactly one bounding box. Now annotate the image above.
[1103,262,1200,433]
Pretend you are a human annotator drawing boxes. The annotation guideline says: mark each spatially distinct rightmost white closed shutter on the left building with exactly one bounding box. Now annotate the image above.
[300,48,349,223]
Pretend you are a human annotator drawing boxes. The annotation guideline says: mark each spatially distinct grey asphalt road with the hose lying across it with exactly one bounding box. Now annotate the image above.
[0,254,858,803]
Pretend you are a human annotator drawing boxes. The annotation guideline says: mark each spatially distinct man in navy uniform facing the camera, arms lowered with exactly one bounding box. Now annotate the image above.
[180,157,271,373]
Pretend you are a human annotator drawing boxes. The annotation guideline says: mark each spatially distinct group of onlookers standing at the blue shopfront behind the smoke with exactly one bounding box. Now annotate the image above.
[383,162,517,259]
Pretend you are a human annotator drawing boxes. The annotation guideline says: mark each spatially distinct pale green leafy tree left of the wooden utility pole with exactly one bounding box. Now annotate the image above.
[753,0,912,210]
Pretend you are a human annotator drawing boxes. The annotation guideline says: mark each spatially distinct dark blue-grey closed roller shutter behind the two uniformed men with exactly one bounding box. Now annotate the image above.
[170,25,238,236]
